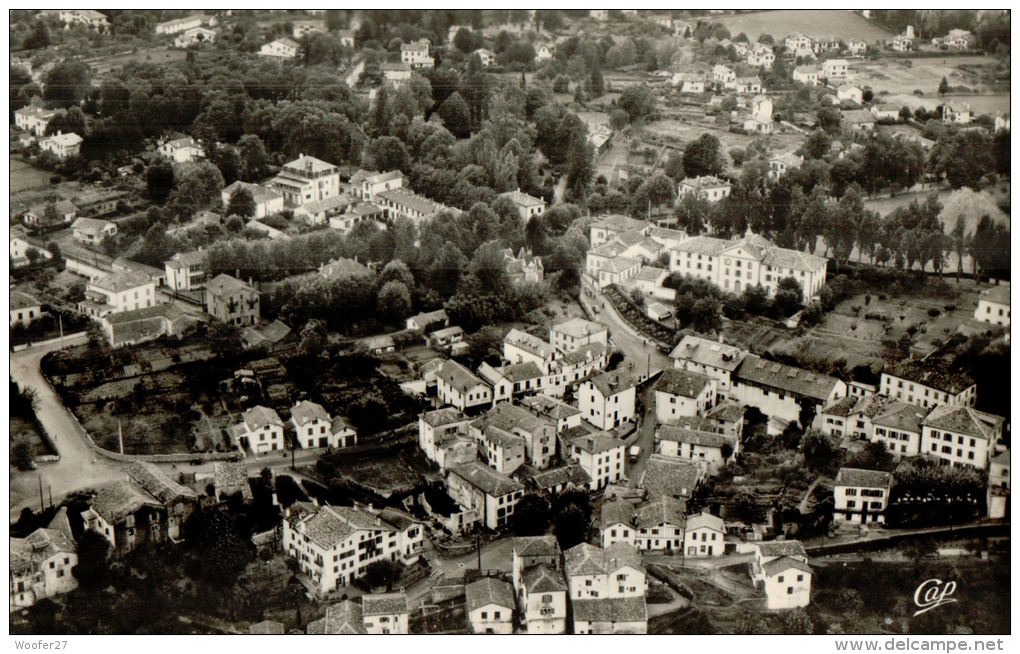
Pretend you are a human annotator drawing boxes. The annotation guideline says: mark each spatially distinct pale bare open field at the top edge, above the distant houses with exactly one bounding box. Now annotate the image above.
[711,9,893,43]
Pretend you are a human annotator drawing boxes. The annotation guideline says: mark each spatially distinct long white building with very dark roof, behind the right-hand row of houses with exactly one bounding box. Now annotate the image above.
[879,360,977,408]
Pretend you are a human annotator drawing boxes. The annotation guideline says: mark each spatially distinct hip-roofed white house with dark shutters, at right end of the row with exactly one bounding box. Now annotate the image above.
[921,405,1006,470]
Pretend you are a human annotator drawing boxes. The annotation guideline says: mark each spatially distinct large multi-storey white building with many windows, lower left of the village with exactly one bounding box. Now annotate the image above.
[283,502,424,595]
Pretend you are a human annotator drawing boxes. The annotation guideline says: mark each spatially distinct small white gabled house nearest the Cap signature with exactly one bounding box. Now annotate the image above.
[751,541,812,610]
